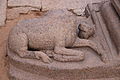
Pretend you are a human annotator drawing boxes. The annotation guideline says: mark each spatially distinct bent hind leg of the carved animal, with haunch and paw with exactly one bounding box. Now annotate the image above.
[8,33,51,63]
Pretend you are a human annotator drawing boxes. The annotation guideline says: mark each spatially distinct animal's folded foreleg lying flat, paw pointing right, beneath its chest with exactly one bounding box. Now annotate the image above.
[54,35,84,61]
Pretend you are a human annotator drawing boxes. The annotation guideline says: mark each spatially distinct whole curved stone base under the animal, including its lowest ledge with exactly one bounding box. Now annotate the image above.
[8,47,120,80]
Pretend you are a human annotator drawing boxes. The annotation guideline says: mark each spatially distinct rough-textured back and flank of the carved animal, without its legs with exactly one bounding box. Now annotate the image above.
[10,9,75,49]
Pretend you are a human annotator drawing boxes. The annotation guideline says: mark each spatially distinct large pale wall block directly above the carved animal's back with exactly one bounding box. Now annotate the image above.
[42,0,108,10]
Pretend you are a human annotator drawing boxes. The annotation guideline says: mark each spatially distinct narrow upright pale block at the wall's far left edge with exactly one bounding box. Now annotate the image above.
[0,0,7,26]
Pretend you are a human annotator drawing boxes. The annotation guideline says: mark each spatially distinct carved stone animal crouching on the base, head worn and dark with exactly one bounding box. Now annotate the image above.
[8,9,104,63]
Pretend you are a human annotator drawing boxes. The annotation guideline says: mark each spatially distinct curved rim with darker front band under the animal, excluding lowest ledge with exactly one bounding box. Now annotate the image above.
[8,48,120,80]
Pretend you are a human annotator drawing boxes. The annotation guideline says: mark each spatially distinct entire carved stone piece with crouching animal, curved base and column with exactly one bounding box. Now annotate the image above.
[7,0,120,80]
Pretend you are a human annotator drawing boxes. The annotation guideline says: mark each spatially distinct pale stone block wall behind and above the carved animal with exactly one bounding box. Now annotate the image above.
[0,0,105,26]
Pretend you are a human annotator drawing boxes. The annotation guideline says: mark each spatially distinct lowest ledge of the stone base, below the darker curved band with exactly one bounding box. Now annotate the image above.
[9,65,120,80]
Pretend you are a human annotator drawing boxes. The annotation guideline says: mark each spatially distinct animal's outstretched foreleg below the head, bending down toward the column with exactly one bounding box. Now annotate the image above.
[72,38,108,62]
